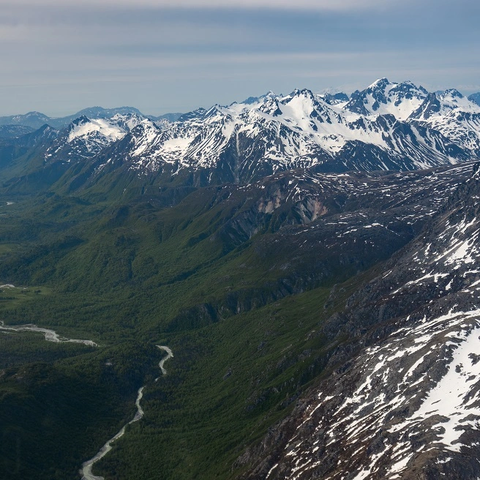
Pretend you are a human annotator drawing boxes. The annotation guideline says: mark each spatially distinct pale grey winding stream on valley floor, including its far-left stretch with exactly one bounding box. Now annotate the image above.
[0,320,173,480]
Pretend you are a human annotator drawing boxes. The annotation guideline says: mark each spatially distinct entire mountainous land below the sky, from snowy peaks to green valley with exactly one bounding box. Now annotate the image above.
[0,78,480,480]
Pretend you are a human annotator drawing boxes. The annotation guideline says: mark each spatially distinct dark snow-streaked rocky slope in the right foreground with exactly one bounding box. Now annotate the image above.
[239,163,480,480]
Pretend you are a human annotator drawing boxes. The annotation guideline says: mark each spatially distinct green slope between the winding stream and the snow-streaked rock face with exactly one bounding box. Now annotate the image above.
[97,289,344,479]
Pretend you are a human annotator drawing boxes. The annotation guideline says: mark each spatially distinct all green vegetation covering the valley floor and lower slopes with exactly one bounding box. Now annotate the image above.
[0,187,380,480]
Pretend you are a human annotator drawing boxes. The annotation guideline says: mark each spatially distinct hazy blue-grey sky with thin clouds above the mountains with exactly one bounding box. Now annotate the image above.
[0,0,480,117]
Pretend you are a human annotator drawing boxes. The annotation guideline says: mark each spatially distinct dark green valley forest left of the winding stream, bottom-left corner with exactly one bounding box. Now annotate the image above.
[0,333,159,480]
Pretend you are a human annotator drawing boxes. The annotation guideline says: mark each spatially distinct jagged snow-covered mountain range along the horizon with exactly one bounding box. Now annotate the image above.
[14,78,472,192]
